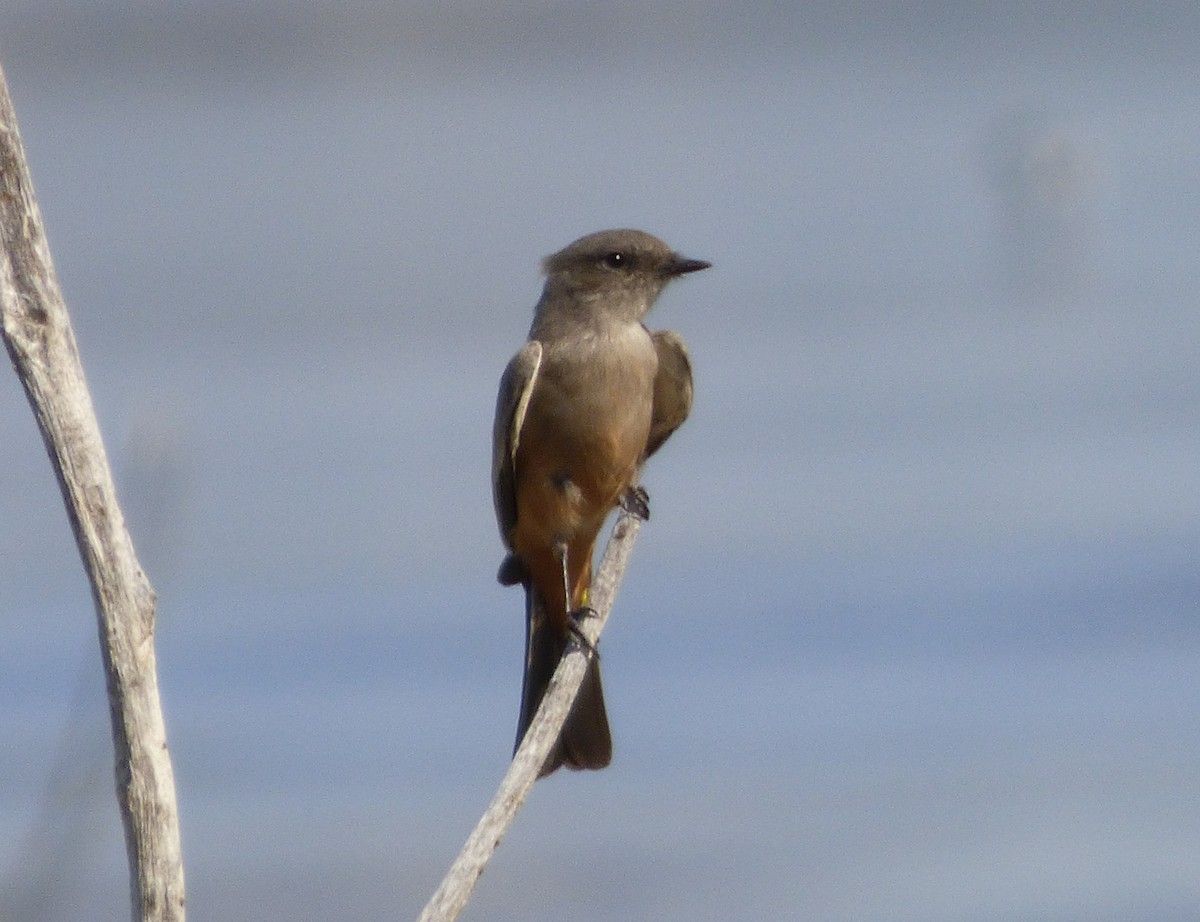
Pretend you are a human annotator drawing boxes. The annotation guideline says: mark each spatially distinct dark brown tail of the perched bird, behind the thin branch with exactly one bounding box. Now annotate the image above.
[516,583,612,778]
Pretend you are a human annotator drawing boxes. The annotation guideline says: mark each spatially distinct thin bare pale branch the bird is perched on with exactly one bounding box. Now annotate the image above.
[418,509,641,922]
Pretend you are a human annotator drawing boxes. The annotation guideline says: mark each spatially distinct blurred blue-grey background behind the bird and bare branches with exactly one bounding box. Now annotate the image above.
[0,0,1200,922]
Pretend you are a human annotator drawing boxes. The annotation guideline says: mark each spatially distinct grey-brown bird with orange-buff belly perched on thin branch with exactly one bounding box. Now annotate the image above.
[492,231,709,776]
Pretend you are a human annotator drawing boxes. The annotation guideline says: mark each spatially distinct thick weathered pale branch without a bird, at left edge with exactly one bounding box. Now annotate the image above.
[0,59,184,922]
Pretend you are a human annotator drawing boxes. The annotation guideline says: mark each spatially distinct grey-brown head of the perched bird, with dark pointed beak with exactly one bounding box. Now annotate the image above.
[538,229,712,321]
